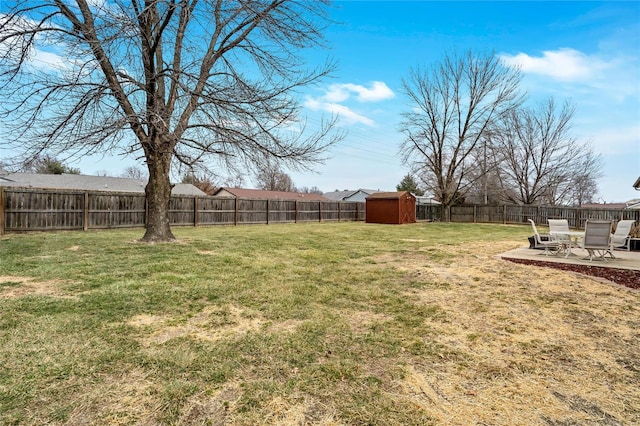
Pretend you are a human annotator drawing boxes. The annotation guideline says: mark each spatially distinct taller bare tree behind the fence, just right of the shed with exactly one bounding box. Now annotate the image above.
[400,51,522,219]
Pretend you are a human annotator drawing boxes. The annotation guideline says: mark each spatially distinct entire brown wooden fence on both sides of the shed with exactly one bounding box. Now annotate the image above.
[0,187,640,234]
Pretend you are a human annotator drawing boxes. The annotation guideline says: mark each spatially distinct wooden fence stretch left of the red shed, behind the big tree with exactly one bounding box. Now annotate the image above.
[0,187,365,233]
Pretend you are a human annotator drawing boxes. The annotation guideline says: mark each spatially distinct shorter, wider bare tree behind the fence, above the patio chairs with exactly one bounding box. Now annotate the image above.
[492,98,602,205]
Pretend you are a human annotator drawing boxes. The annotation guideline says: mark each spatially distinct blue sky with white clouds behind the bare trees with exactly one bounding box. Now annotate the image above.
[5,1,640,202]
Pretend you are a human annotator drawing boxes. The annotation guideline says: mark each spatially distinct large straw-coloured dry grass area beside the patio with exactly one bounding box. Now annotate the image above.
[376,243,640,425]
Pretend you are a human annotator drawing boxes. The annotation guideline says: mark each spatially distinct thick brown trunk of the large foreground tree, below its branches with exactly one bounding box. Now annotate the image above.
[141,154,176,243]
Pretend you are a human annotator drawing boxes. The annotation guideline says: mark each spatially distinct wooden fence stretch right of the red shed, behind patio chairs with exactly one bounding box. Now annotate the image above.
[416,205,640,229]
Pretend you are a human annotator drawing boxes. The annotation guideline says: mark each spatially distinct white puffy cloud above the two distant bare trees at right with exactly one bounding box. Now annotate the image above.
[500,48,609,81]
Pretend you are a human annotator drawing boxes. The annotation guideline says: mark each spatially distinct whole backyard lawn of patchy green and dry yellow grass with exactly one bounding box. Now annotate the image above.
[0,222,640,426]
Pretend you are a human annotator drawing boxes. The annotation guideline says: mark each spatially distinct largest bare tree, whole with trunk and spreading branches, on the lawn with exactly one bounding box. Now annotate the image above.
[0,0,337,242]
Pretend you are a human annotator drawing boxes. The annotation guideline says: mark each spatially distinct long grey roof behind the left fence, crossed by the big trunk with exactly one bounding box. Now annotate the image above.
[0,173,206,195]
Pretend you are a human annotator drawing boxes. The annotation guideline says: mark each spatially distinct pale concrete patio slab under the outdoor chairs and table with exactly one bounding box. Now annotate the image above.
[499,246,640,271]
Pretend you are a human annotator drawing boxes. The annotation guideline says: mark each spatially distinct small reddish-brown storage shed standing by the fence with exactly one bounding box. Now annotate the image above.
[366,191,416,224]
